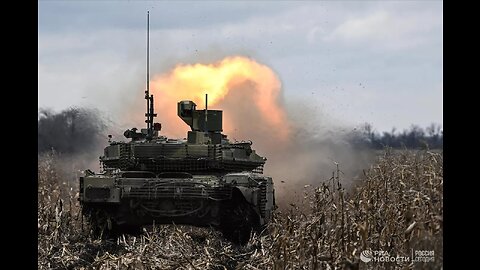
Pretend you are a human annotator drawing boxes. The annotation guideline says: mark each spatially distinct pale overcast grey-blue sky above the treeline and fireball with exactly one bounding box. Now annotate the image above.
[38,1,443,131]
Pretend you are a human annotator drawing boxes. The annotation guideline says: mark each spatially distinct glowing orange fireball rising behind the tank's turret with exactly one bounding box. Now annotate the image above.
[151,56,289,141]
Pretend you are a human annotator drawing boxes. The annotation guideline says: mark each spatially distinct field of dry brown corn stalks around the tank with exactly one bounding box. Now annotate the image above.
[38,149,443,269]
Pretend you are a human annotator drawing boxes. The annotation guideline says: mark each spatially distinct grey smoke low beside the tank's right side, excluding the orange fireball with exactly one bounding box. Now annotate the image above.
[265,116,375,208]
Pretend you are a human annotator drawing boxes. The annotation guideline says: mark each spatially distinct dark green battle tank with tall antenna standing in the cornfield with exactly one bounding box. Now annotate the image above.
[79,11,276,244]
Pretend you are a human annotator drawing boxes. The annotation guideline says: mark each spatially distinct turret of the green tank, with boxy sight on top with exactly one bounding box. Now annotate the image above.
[100,95,266,175]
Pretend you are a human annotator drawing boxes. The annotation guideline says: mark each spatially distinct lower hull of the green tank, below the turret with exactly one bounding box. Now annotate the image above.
[80,172,274,243]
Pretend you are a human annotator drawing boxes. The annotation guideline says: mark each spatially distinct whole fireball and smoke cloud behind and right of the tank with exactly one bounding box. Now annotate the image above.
[152,56,374,206]
